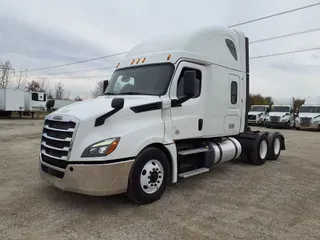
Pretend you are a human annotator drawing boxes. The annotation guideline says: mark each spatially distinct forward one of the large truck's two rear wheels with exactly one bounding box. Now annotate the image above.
[249,133,268,165]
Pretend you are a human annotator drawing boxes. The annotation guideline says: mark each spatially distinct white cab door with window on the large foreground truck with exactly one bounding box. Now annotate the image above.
[169,62,205,140]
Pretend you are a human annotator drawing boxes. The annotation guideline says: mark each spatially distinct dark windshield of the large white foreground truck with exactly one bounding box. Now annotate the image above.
[105,63,174,96]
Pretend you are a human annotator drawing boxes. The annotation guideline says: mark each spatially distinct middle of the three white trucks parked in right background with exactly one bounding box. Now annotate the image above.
[265,97,295,128]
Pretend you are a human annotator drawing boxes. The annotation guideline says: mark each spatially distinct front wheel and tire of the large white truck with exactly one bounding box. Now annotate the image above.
[127,147,169,205]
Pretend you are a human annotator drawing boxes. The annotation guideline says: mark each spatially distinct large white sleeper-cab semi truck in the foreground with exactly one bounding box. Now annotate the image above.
[39,27,285,204]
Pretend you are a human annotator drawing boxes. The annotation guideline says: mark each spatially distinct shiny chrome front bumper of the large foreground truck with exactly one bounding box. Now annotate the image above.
[39,157,134,196]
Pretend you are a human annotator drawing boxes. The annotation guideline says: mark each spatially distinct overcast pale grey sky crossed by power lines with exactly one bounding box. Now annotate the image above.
[0,0,320,99]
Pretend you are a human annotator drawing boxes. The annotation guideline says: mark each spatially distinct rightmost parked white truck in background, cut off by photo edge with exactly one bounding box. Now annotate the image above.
[296,97,320,130]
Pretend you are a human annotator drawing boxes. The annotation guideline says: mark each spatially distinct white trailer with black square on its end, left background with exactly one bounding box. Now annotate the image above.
[24,91,47,117]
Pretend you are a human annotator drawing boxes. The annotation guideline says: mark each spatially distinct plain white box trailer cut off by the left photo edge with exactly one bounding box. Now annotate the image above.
[0,88,24,117]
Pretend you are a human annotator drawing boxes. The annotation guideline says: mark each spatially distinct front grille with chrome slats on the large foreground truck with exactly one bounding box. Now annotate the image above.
[41,119,76,171]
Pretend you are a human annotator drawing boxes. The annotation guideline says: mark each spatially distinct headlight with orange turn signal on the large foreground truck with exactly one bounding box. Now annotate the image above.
[81,138,120,157]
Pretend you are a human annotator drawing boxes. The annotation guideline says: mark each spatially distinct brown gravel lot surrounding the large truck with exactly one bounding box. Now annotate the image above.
[0,120,320,240]
